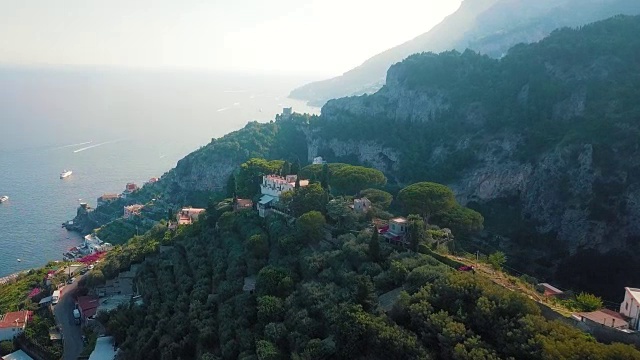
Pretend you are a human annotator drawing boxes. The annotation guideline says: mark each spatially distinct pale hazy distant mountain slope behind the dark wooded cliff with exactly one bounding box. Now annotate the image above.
[290,0,640,106]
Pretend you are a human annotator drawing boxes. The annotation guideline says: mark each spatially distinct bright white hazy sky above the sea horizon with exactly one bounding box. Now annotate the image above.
[0,0,461,75]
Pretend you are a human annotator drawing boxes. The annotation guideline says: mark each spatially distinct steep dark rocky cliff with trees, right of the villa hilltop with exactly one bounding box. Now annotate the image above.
[306,17,640,298]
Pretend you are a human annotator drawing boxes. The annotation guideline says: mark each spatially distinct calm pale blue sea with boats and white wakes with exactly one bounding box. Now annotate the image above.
[0,67,320,277]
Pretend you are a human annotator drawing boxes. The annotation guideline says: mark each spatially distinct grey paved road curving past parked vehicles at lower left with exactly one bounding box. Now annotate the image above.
[53,272,84,360]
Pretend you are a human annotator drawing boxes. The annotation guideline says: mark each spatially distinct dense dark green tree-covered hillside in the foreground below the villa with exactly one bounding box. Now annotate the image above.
[99,181,640,360]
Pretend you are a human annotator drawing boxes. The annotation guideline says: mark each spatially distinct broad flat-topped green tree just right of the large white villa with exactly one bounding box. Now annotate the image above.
[330,166,387,195]
